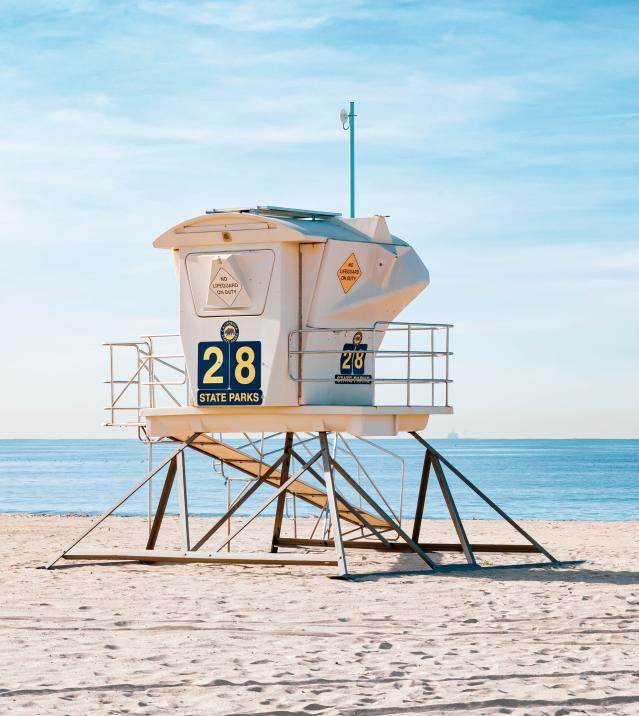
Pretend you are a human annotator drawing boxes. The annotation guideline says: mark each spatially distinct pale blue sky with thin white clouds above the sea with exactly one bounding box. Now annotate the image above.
[0,0,639,438]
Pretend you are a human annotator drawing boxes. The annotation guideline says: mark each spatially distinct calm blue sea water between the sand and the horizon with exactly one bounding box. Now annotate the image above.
[0,439,639,520]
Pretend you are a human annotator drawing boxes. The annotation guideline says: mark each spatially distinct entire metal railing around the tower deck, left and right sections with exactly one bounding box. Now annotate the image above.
[104,321,452,434]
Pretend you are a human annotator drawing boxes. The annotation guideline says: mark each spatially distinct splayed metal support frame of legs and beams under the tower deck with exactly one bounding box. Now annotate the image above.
[46,432,563,578]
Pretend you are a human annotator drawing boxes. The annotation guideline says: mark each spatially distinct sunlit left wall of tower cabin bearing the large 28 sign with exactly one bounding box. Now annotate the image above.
[180,243,299,407]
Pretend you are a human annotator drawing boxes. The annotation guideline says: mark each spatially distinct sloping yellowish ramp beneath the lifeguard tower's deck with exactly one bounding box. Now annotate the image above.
[181,435,392,530]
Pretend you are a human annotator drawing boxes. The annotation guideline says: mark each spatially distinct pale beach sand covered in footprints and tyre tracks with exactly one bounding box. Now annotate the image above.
[0,515,639,716]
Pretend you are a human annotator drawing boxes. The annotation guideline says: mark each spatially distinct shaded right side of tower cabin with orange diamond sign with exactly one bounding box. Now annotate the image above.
[300,240,429,405]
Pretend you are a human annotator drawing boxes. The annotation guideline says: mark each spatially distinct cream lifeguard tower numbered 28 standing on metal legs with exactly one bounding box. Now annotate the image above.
[47,206,557,577]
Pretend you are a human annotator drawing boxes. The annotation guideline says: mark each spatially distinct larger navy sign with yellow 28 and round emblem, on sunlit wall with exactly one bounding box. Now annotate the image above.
[197,321,262,407]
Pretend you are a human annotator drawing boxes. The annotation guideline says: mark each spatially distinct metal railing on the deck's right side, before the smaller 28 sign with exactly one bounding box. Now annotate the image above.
[288,321,453,407]
